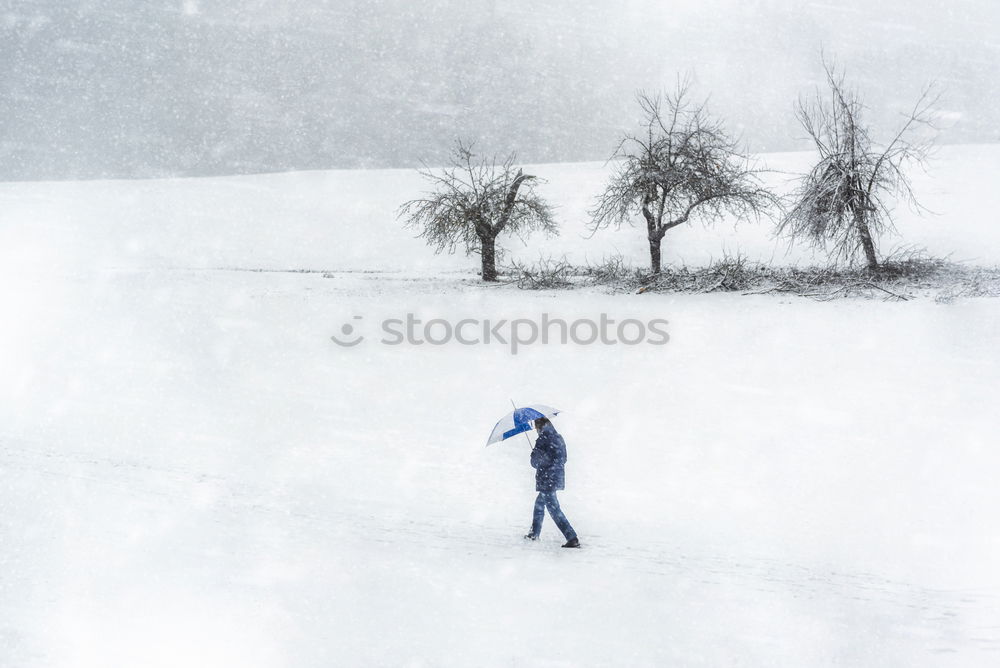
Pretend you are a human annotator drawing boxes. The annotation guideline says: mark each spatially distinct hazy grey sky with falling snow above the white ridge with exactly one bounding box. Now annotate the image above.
[0,0,1000,178]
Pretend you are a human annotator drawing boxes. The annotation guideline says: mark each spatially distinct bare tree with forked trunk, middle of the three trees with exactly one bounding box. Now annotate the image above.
[590,80,777,274]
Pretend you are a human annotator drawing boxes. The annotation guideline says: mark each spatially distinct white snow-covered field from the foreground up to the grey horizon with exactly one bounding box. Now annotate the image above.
[0,146,1000,667]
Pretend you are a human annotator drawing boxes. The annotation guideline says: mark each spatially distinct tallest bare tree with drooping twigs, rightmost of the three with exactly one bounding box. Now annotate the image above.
[778,60,937,270]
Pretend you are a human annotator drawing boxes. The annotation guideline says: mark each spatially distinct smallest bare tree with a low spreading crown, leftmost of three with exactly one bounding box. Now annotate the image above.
[398,140,557,281]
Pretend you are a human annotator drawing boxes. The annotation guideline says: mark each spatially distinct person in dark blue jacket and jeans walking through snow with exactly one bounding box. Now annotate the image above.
[525,417,580,547]
